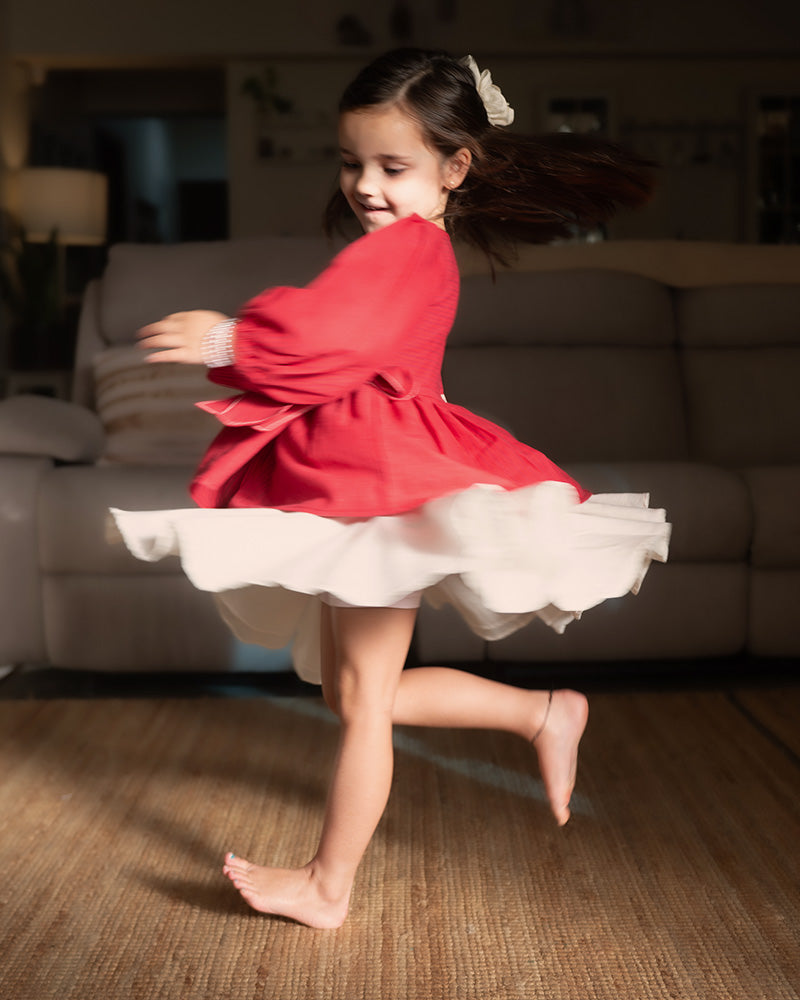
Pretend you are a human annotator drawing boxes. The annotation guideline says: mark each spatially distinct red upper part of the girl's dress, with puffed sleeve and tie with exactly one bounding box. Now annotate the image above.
[192,216,589,517]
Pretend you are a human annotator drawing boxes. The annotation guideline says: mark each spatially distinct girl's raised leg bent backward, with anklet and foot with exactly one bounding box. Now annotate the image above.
[393,667,589,826]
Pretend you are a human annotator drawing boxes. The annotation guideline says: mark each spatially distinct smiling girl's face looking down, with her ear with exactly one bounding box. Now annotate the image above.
[339,105,470,233]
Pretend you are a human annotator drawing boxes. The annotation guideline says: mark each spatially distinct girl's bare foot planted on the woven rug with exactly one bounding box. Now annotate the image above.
[222,854,350,930]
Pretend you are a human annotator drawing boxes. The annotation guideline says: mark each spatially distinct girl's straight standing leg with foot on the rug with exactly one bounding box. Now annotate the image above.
[223,608,416,927]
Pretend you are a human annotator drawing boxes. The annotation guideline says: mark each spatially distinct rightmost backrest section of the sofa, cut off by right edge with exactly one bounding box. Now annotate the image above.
[676,285,800,467]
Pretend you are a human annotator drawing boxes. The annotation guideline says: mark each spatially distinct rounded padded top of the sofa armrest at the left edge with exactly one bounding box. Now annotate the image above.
[0,395,105,462]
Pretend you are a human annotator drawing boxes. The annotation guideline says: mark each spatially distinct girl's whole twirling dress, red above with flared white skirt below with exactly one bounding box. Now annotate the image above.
[114,210,669,680]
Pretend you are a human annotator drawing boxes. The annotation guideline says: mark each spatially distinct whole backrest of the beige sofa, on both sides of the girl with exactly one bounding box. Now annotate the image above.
[73,237,800,466]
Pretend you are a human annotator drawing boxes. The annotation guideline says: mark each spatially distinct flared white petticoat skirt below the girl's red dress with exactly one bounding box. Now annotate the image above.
[112,482,670,682]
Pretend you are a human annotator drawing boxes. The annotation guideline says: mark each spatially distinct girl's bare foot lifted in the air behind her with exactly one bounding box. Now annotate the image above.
[532,690,589,826]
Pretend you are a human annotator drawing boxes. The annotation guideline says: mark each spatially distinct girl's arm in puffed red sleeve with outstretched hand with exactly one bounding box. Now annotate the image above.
[138,217,447,405]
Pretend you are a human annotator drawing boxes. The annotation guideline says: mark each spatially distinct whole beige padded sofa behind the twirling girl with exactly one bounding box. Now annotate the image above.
[0,239,800,671]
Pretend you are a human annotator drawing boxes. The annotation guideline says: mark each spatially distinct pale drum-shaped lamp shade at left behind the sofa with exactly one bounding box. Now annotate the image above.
[17,167,108,246]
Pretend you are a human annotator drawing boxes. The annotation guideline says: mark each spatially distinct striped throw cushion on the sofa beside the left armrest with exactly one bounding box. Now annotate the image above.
[94,347,231,465]
